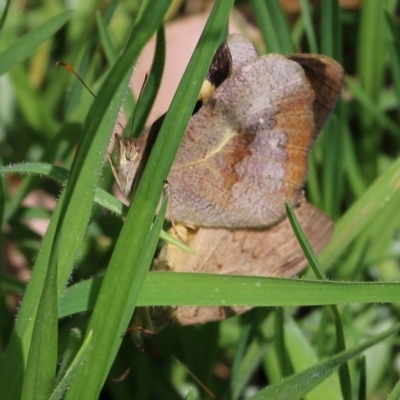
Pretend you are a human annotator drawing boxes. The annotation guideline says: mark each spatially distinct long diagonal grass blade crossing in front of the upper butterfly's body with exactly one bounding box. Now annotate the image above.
[67,1,232,398]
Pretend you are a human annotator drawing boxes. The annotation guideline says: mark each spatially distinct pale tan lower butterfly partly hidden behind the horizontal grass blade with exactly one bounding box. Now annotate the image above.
[133,201,333,332]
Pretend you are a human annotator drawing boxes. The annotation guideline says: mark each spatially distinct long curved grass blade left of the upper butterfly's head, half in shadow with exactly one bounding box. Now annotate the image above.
[0,4,167,399]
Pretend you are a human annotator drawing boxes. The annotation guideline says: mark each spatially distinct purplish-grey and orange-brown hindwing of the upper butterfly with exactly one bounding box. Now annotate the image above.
[168,55,316,229]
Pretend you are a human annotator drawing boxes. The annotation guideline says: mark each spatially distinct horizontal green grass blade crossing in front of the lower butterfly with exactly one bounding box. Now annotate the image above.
[59,272,400,318]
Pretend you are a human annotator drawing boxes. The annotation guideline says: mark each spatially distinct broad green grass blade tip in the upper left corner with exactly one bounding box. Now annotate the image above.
[0,11,72,76]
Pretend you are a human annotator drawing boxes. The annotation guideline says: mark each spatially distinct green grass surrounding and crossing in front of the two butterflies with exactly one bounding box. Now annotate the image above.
[0,0,400,400]
